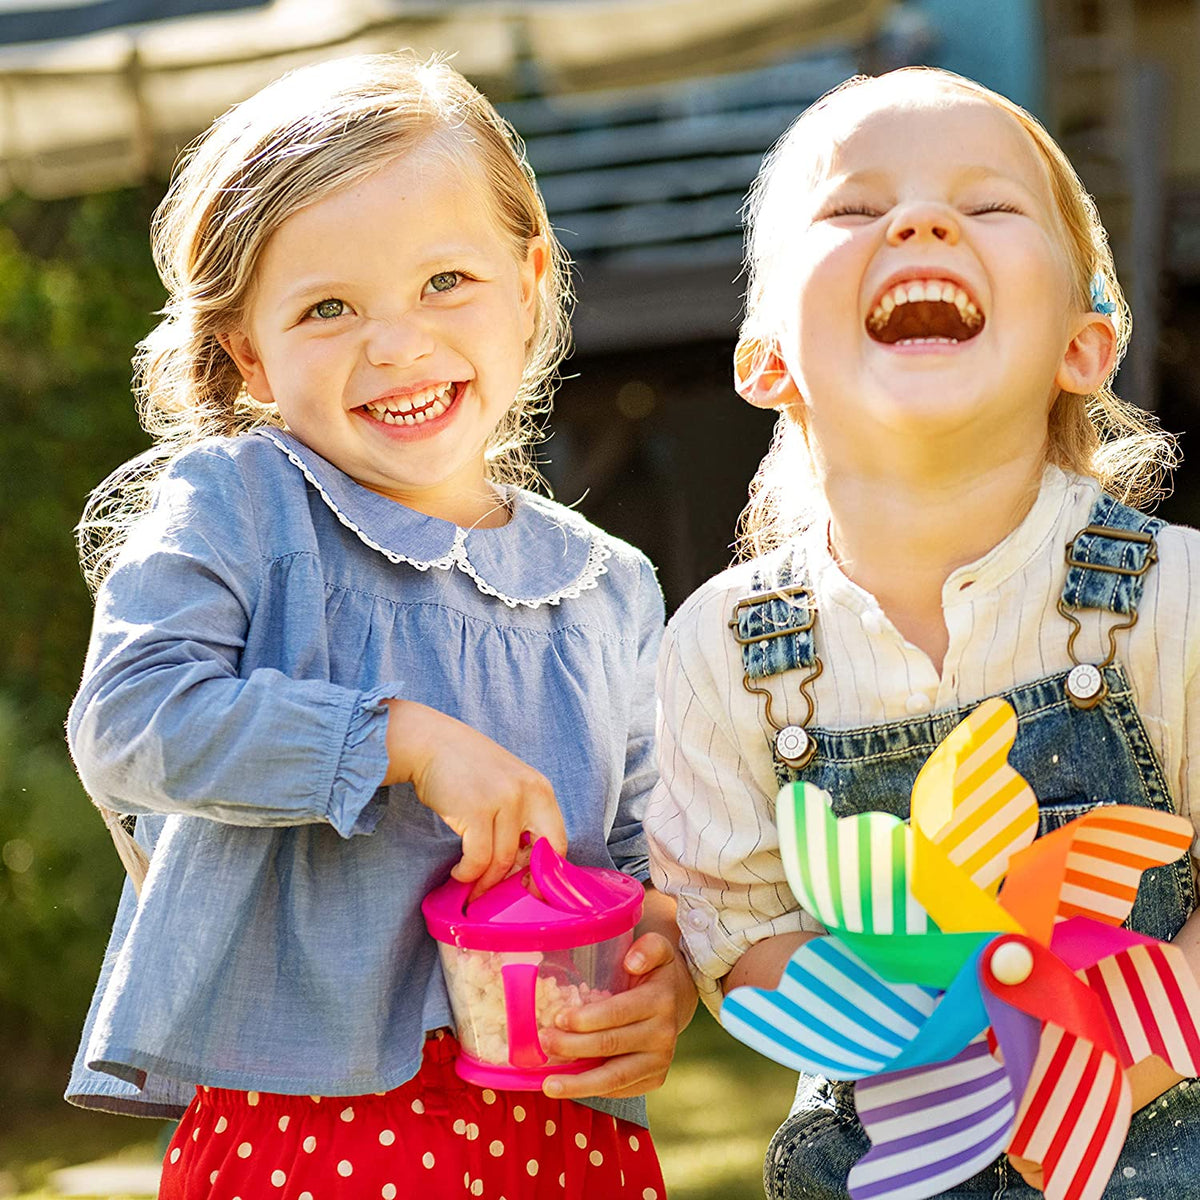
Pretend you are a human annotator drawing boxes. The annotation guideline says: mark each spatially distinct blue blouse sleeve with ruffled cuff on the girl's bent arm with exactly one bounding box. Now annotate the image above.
[67,449,401,838]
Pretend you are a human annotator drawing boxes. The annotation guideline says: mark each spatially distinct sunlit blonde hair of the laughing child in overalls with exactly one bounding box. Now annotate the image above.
[736,67,1178,558]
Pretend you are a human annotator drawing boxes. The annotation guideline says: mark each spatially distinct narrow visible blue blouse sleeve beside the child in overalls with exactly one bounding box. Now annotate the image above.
[608,559,665,883]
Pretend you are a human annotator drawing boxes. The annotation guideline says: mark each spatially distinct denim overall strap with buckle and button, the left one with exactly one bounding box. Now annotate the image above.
[728,556,823,768]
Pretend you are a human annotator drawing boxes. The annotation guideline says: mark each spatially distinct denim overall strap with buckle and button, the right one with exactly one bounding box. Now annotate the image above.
[1058,494,1166,709]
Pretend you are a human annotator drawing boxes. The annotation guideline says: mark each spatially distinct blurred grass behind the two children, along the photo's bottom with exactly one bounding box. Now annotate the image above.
[0,1009,796,1200]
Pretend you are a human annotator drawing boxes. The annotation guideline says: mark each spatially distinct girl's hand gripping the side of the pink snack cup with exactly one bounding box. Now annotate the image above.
[540,934,696,1099]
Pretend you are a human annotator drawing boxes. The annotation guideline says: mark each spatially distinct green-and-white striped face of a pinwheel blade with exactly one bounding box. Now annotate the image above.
[775,782,930,934]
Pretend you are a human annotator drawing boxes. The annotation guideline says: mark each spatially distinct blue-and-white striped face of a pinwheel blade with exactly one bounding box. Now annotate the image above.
[721,936,937,1079]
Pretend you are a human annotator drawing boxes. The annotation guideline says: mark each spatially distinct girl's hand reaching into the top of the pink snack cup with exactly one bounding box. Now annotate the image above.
[384,700,566,895]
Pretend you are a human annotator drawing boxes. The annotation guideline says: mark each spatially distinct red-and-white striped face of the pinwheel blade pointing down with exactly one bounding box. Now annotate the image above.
[1008,1022,1132,1200]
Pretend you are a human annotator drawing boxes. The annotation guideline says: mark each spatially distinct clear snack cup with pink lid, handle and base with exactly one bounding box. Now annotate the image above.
[421,838,644,1091]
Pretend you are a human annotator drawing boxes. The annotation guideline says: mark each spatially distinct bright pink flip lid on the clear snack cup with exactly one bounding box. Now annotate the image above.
[421,838,644,950]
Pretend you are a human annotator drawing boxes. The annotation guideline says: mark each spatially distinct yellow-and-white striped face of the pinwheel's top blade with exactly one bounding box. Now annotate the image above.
[912,700,1038,888]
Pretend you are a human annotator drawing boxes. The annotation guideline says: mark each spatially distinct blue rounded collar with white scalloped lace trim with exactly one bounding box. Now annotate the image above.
[256,430,612,608]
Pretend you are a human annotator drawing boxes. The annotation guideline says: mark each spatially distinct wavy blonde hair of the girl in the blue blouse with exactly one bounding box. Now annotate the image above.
[77,53,571,592]
